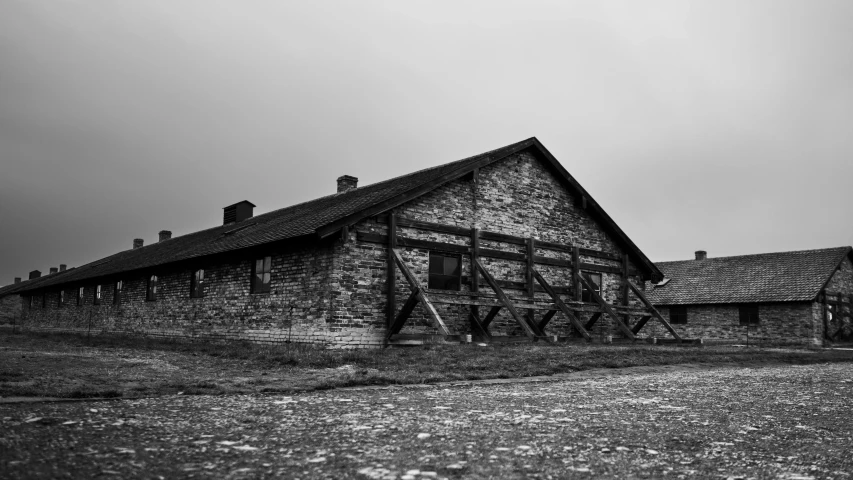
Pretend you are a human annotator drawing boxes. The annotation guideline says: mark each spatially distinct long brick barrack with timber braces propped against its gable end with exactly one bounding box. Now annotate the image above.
[1,138,677,346]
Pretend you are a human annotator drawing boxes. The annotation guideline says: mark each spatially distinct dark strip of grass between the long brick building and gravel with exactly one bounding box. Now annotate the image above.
[0,333,853,396]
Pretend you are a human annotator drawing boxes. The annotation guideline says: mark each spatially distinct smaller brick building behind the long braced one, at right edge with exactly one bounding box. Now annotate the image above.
[647,247,853,346]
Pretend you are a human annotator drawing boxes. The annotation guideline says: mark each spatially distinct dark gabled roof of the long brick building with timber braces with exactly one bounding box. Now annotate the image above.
[7,137,660,294]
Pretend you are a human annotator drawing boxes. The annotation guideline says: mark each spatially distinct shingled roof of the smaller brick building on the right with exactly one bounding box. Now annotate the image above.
[646,247,853,305]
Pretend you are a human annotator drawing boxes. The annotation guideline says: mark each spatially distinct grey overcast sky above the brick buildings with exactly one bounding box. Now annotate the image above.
[0,0,853,285]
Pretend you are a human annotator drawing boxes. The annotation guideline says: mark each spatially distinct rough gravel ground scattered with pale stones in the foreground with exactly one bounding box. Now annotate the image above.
[0,363,853,479]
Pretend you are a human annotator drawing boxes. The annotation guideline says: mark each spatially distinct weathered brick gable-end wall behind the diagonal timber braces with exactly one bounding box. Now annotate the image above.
[335,153,643,337]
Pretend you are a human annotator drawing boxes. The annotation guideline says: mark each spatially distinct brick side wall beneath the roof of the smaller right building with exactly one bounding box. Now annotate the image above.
[650,302,822,346]
